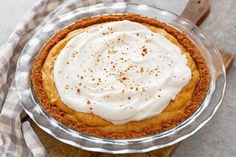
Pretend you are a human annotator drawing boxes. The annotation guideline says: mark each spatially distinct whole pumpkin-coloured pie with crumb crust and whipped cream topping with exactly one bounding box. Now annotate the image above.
[31,14,209,139]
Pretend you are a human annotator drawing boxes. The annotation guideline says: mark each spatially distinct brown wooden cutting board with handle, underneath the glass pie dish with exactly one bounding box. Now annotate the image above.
[30,0,234,157]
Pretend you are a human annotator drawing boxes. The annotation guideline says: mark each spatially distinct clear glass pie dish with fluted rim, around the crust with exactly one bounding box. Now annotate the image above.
[16,2,226,154]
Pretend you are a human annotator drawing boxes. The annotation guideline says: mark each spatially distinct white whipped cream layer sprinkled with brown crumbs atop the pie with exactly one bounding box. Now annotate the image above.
[53,20,191,125]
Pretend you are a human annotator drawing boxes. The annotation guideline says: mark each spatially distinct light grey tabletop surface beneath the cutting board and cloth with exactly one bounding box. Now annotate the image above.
[0,0,236,157]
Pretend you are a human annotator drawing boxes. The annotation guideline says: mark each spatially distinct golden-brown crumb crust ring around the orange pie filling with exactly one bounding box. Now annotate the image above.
[31,14,209,138]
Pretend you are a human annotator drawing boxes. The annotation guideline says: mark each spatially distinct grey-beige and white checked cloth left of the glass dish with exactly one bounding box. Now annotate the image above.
[0,0,127,157]
